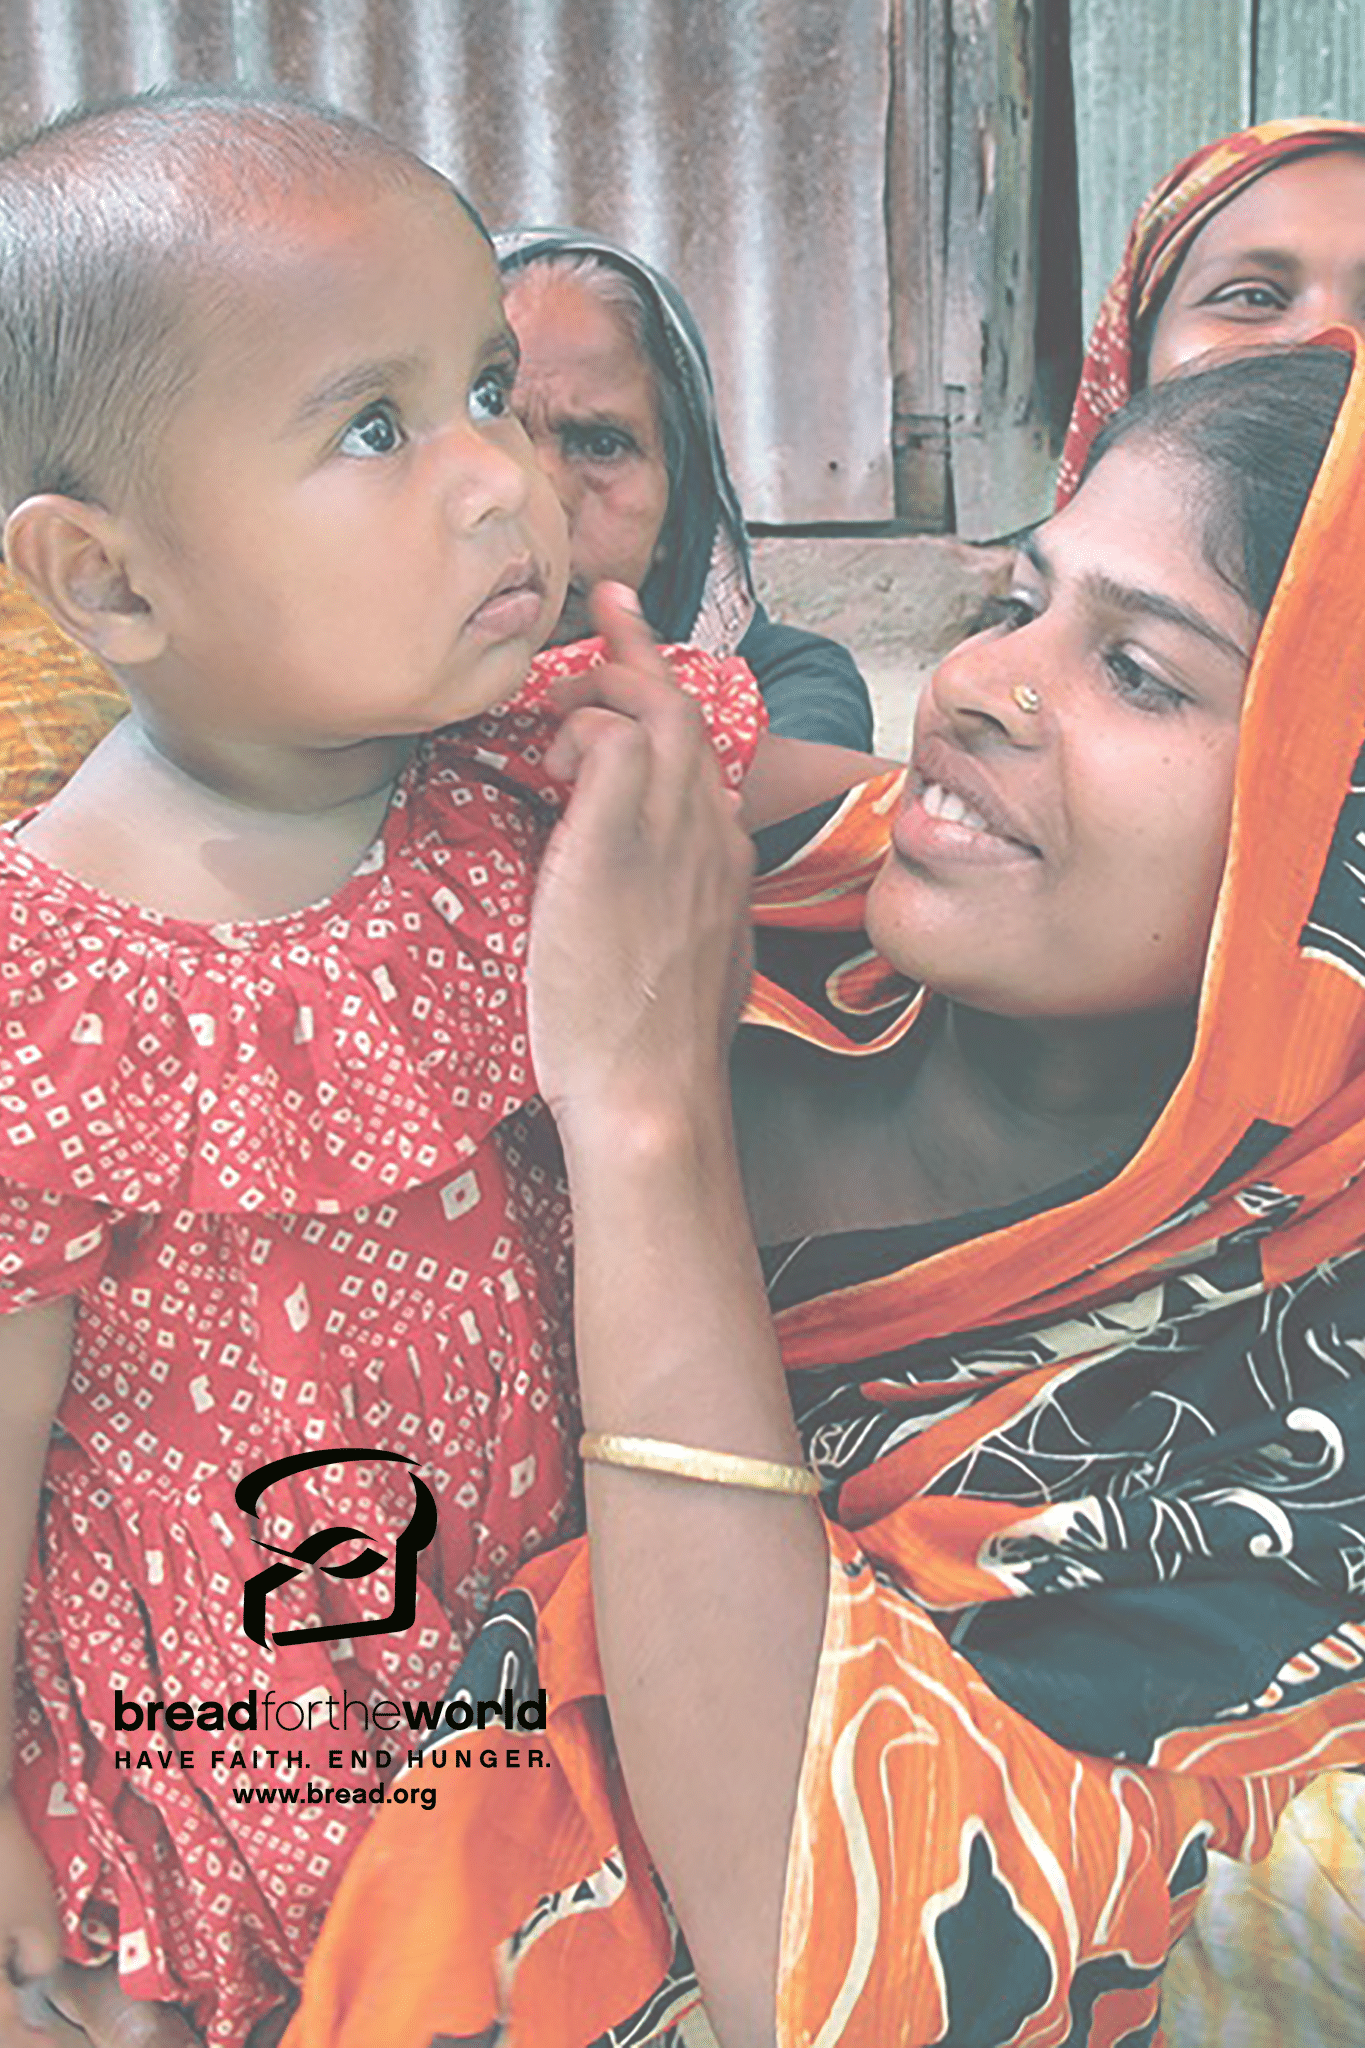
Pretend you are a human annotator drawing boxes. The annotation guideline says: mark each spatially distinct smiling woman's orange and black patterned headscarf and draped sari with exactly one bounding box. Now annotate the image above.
[287,330,1365,2048]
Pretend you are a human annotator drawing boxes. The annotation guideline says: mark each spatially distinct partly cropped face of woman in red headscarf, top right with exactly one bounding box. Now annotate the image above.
[1148,150,1365,383]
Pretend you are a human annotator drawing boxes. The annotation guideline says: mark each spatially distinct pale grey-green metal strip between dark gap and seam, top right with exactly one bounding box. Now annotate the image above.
[1070,0,1252,328]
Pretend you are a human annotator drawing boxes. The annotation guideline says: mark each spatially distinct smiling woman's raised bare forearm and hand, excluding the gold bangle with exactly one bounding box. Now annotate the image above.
[530,588,829,2048]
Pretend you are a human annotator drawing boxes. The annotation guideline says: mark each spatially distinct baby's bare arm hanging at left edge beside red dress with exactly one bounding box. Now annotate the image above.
[0,1296,74,2048]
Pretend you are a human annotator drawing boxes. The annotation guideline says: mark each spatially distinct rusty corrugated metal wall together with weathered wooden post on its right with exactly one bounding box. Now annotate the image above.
[0,0,1048,532]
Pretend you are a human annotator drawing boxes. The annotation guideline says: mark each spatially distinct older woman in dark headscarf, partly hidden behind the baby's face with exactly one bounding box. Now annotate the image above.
[497,227,872,752]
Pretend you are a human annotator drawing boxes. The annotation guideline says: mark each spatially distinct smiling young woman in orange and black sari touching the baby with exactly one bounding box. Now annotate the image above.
[289,348,1365,2048]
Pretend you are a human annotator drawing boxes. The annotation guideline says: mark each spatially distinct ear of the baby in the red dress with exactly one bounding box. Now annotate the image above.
[4,492,166,668]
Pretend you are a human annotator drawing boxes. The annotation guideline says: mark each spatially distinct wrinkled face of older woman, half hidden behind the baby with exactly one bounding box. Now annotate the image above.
[505,266,669,645]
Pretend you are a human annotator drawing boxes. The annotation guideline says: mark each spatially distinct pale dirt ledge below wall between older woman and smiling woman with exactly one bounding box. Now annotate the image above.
[753,535,1011,756]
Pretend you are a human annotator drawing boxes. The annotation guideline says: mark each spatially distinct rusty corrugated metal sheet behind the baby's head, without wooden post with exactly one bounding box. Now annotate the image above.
[0,0,892,522]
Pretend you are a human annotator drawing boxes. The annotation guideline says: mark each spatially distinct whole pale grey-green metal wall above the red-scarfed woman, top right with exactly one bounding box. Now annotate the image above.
[1080,0,1365,326]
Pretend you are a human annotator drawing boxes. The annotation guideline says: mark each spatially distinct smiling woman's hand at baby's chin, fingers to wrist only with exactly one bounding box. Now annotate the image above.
[528,584,753,1122]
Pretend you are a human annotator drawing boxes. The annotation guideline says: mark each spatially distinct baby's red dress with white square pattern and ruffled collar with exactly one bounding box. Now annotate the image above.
[0,643,763,2048]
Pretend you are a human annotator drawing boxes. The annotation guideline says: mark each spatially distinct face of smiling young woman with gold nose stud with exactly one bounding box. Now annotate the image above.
[868,438,1257,1018]
